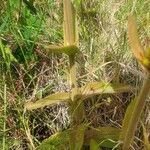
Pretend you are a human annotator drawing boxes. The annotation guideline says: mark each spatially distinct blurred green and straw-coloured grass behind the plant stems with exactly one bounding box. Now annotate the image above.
[0,0,150,150]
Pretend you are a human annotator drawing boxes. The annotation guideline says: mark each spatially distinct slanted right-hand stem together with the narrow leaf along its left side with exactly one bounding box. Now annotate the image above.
[120,74,150,150]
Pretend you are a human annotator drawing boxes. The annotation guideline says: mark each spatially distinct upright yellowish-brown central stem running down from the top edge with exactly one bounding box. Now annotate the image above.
[63,0,84,126]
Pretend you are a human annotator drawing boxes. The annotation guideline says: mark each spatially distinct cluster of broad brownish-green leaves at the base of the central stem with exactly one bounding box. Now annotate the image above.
[38,124,120,150]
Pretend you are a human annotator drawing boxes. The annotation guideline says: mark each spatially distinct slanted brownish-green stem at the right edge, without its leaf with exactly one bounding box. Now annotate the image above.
[120,74,150,150]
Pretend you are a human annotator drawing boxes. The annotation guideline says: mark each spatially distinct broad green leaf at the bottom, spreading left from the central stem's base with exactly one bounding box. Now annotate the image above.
[37,124,86,150]
